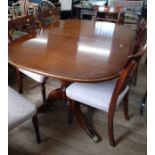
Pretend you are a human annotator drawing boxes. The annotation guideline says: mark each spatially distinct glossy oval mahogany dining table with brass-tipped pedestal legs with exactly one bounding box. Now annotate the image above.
[8,19,135,142]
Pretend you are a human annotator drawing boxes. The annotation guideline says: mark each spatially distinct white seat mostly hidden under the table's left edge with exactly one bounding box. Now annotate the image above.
[19,68,45,83]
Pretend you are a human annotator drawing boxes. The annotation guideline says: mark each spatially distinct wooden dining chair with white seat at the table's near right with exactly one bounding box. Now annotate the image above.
[66,46,146,146]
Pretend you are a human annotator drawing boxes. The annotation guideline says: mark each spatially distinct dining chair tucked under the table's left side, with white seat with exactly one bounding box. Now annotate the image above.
[8,15,47,103]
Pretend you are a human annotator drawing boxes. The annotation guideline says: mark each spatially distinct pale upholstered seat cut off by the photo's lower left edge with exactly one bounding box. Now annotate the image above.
[8,87,37,131]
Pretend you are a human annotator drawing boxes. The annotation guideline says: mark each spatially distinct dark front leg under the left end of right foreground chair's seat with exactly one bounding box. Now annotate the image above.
[67,99,75,125]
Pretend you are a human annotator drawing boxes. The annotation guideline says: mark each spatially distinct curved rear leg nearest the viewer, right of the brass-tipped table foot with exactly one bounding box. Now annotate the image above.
[108,112,116,147]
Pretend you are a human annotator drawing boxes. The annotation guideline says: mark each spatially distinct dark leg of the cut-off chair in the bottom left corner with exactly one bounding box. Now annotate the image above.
[32,115,40,143]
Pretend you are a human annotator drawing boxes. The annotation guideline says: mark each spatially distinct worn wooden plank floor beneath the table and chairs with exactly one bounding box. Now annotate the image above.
[8,58,147,155]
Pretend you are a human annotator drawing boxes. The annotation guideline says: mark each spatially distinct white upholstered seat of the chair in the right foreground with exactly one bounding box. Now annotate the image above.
[66,79,129,112]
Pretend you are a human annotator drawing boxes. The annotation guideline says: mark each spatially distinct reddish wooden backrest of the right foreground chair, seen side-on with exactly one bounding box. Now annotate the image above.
[109,45,147,111]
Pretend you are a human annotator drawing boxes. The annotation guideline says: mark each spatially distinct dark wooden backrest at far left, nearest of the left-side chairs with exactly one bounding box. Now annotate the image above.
[8,15,35,42]
